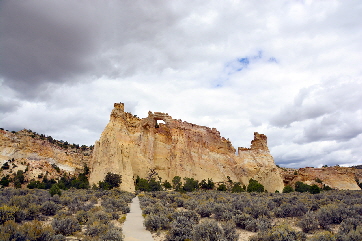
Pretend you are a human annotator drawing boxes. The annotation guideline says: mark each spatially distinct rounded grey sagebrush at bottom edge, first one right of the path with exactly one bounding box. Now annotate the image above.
[166,216,194,241]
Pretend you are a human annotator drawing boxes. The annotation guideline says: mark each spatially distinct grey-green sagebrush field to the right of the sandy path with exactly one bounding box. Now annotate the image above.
[139,191,362,241]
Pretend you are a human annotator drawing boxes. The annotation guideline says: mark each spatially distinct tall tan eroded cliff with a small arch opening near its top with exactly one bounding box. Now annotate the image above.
[90,103,284,192]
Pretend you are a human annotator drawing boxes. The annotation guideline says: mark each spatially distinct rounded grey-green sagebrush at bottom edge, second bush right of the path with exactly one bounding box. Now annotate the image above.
[192,219,224,241]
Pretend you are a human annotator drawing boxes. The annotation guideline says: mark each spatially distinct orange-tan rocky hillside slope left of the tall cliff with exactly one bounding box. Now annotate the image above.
[0,130,92,185]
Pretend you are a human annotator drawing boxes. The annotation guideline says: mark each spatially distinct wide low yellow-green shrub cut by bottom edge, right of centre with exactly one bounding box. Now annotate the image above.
[249,224,306,241]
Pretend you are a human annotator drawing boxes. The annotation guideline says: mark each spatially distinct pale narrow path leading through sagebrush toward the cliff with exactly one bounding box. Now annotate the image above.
[122,196,154,241]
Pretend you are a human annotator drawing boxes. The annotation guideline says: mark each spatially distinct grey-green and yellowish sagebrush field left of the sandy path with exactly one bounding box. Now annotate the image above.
[0,188,134,241]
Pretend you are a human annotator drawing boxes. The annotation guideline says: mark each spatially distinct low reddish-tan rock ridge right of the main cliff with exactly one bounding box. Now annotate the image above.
[281,166,362,190]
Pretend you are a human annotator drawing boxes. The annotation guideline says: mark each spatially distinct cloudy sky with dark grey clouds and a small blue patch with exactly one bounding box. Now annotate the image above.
[0,0,362,167]
